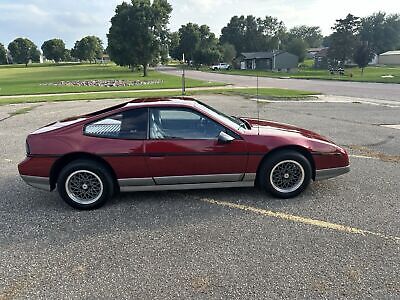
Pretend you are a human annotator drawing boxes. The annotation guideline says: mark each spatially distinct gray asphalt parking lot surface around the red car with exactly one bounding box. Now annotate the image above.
[0,96,400,299]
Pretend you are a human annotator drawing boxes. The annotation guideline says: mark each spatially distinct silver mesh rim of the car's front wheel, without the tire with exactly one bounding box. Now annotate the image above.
[269,160,305,193]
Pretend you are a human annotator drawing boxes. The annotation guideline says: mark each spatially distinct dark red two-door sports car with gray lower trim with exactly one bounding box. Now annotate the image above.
[18,97,350,209]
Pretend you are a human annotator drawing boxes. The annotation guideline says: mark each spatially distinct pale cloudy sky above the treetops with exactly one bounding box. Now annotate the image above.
[0,0,400,48]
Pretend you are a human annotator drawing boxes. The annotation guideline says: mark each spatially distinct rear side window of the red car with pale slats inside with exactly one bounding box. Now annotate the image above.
[84,108,148,140]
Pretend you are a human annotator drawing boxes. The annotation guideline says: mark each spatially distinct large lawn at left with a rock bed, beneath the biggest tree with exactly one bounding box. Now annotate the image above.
[0,64,223,96]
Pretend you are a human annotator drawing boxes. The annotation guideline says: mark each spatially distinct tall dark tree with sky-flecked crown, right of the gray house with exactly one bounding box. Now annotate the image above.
[328,14,360,64]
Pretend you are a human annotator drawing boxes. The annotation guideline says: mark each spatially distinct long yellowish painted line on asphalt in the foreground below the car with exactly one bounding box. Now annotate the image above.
[200,198,400,243]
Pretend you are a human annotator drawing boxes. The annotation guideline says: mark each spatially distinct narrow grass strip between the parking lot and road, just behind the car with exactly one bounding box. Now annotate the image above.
[0,88,317,105]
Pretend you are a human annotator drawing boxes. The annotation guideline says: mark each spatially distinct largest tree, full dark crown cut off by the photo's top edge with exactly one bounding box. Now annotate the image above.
[107,0,172,76]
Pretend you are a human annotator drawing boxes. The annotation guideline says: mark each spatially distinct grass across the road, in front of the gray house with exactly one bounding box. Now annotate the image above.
[208,67,400,83]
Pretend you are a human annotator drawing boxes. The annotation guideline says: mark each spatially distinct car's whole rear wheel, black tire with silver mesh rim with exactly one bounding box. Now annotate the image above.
[57,159,114,210]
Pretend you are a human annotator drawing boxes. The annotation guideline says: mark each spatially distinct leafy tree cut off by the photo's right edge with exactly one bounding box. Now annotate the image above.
[360,12,400,54]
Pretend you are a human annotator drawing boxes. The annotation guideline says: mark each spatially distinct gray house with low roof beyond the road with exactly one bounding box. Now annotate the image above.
[239,50,299,72]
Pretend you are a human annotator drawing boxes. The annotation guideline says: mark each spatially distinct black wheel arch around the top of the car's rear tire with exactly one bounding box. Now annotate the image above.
[50,152,119,190]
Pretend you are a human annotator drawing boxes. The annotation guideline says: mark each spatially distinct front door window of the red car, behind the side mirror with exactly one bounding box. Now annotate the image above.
[150,108,226,140]
